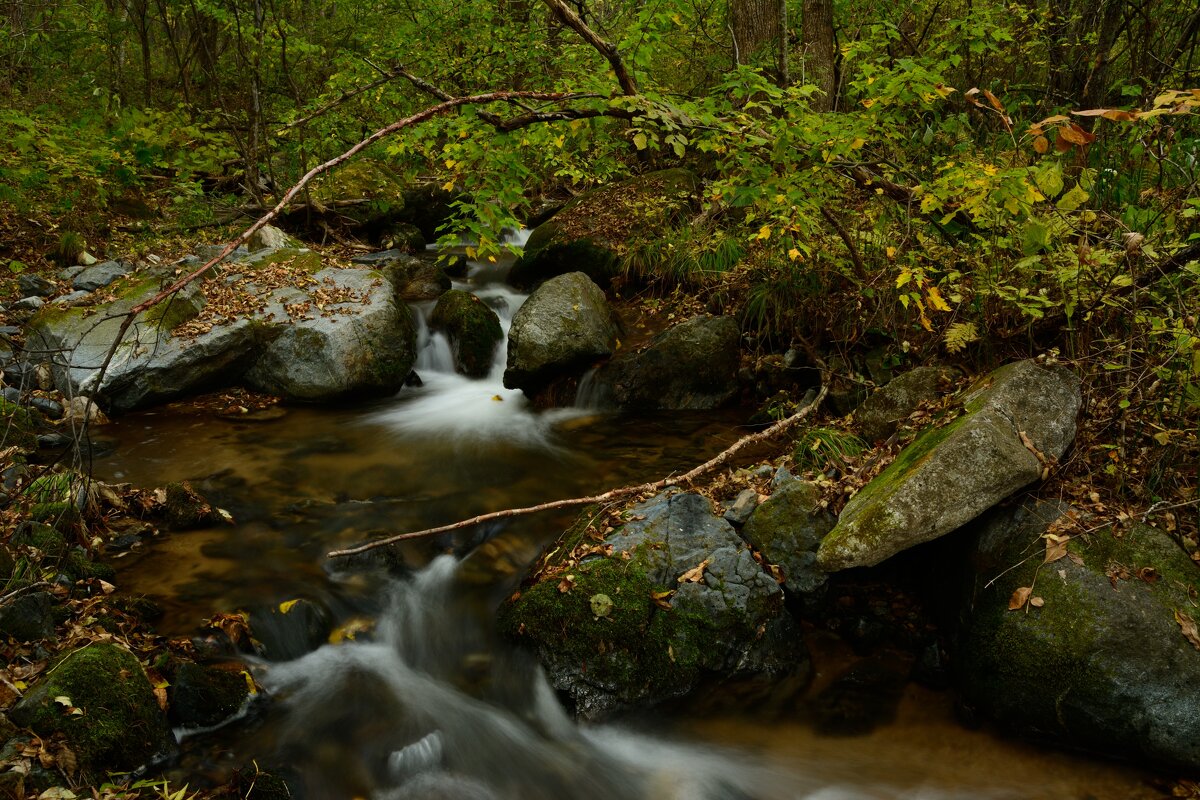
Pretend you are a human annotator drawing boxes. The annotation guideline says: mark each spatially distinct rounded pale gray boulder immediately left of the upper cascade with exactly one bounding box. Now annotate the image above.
[245,269,416,401]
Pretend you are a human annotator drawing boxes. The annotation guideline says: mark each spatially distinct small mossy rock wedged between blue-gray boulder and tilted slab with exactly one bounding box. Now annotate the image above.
[742,479,836,600]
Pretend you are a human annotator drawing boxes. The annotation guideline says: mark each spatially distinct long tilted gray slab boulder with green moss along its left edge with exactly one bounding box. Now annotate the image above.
[817,361,1082,572]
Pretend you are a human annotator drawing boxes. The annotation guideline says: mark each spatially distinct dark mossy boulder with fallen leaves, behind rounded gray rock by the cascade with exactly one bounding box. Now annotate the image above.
[509,168,701,288]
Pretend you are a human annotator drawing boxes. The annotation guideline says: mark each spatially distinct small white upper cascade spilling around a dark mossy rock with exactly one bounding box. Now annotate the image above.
[368,236,583,447]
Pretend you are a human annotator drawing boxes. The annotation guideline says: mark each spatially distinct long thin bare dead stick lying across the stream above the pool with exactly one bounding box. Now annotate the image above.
[326,381,828,558]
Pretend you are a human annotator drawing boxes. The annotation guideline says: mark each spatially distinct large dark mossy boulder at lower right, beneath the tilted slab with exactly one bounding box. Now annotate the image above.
[954,501,1200,770]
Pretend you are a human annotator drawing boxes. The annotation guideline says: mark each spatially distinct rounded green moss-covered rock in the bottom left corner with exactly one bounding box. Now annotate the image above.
[10,643,175,777]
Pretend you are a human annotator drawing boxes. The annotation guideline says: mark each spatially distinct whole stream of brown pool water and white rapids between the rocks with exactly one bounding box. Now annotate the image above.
[97,244,1154,800]
